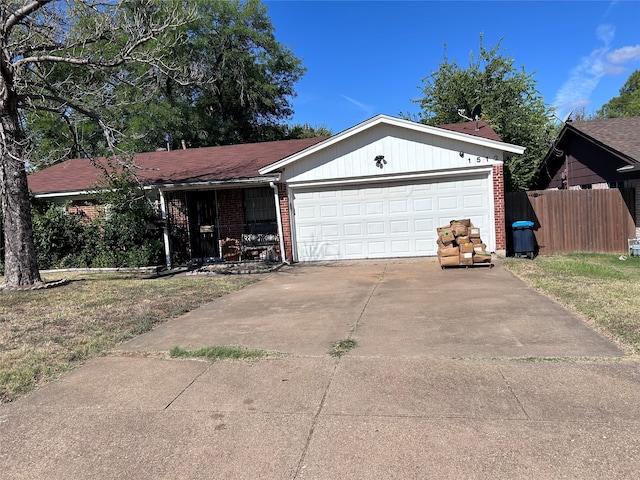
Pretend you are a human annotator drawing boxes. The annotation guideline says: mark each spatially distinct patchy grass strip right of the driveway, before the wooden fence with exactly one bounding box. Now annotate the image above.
[503,254,640,354]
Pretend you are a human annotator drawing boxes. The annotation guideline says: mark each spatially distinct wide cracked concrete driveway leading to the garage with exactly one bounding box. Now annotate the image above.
[0,258,640,479]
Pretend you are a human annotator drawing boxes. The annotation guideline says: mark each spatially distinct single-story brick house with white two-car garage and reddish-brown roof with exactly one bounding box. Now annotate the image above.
[29,115,524,263]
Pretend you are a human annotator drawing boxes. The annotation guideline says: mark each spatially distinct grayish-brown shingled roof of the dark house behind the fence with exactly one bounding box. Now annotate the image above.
[561,117,640,162]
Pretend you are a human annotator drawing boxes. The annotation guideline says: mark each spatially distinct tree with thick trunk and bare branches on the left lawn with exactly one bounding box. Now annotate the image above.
[0,0,189,286]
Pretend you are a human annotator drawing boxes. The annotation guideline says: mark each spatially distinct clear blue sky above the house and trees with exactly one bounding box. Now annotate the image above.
[264,0,640,133]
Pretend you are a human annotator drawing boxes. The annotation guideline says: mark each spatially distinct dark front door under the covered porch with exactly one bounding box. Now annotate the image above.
[187,191,220,261]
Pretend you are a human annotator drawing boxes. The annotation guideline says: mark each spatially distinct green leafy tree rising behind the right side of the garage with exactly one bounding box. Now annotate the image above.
[416,35,553,190]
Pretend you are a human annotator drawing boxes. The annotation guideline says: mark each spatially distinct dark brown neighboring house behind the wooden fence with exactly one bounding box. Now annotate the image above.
[537,117,640,234]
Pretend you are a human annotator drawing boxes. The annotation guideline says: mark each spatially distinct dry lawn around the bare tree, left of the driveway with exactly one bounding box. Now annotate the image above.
[0,273,258,403]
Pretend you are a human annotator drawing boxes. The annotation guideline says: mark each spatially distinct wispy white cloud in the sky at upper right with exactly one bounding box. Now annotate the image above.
[554,24,640,116]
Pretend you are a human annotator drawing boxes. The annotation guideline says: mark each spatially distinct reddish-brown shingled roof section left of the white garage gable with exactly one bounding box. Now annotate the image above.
[28,137,326,194]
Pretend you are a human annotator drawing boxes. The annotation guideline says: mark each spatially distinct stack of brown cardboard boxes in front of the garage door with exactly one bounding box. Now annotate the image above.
[438,219,491,267]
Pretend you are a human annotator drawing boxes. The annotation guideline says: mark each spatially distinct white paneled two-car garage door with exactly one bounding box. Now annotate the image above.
[293,174,493,261]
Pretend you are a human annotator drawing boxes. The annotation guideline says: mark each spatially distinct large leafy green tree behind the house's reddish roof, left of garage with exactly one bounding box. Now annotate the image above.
[30,0,304,158]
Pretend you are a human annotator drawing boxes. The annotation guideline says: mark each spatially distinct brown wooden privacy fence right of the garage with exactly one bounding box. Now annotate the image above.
[505,188,635,255]
